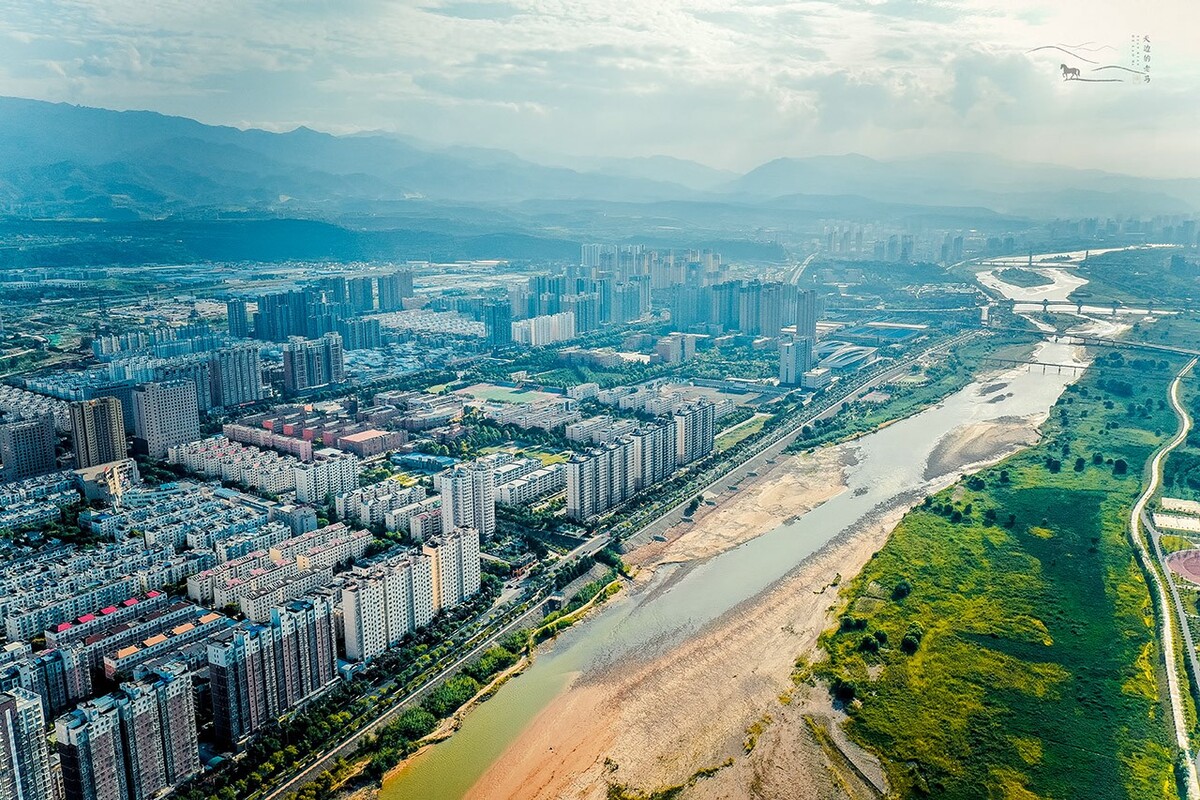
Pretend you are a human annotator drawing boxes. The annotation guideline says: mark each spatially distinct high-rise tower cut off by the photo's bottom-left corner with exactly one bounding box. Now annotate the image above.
[0,688,55,800]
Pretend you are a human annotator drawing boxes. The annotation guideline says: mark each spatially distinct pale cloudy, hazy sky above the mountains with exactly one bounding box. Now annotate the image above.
[0,0,1200,176]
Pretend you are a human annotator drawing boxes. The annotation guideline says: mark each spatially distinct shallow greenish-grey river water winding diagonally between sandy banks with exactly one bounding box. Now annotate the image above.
[383,333,1080,800]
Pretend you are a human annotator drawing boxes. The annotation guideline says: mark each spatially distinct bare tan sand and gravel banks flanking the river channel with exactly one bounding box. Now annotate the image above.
[467,410,1039,800]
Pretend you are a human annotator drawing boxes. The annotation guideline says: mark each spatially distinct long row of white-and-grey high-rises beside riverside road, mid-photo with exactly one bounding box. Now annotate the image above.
[566,399,716,522]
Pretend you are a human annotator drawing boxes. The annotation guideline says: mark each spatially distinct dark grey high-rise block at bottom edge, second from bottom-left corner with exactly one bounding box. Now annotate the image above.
[54,663,200,800]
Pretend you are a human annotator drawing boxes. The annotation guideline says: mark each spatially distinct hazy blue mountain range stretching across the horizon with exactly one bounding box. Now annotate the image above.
[0,97,1200,262]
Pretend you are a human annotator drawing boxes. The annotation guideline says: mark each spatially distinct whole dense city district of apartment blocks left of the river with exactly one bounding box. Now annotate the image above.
[0,230,1185,800]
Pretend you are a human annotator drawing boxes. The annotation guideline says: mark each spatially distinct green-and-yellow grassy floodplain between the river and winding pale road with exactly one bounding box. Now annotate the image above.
[820,347,1182,800]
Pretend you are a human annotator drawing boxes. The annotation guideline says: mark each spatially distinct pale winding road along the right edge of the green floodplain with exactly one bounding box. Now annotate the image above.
[1129,359,1200,800]
